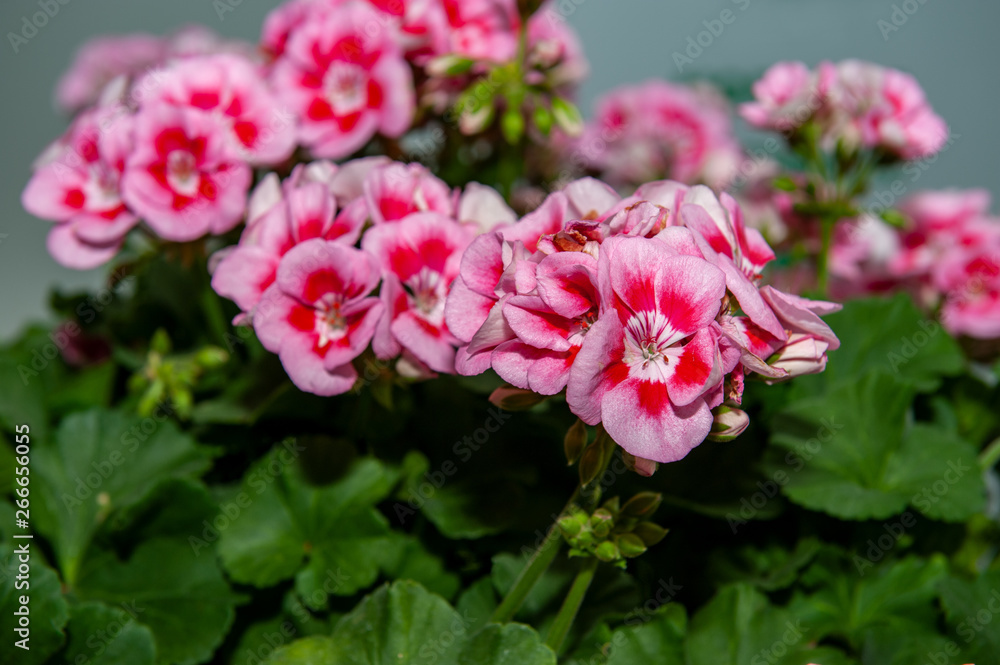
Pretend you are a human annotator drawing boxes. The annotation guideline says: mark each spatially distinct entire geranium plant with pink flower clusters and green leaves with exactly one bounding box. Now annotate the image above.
[0,0,1000,665]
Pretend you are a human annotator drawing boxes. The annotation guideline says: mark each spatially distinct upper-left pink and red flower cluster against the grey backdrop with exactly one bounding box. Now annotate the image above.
[22,27,295,269]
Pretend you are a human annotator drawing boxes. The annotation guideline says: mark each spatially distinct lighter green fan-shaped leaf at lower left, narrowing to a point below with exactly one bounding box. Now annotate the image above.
[32,409,209,586]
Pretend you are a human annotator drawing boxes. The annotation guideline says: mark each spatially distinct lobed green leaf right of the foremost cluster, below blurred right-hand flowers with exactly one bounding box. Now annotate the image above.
[792,294,965,395]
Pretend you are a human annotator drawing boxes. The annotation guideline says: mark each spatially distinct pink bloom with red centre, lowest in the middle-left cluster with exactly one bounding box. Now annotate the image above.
[253,238,383,395]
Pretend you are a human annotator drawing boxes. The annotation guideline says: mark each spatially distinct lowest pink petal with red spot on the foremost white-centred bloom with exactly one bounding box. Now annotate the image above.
[601,379,712,462]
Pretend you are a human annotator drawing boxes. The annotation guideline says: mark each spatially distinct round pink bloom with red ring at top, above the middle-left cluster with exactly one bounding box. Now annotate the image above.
[272,2,414,158]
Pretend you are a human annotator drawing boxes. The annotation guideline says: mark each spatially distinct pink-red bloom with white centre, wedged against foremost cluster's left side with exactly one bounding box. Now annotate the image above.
[362,212,475,373]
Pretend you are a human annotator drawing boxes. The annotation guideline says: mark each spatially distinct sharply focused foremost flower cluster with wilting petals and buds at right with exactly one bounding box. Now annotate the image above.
[445,179,838,472]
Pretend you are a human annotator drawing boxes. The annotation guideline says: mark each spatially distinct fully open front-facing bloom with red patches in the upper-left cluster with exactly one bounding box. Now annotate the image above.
[122,104,251,242]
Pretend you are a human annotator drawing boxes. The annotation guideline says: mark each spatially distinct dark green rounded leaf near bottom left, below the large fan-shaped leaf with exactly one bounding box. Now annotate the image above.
[76,538,240,665]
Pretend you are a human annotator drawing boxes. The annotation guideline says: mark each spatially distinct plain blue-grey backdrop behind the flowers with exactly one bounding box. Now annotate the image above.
[0,0,1000,339]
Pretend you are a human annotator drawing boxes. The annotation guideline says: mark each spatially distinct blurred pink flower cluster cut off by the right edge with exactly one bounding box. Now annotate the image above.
[832,190,1000,340]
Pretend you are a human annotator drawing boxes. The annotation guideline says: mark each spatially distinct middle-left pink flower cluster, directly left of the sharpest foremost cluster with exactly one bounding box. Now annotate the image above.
[212,157,514,395]
